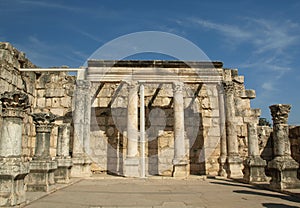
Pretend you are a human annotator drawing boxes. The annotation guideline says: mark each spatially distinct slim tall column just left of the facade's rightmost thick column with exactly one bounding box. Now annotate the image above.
[217,85,227,177]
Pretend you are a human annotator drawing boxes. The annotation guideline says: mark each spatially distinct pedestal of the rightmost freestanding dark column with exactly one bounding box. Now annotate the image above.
[268,156,300,190]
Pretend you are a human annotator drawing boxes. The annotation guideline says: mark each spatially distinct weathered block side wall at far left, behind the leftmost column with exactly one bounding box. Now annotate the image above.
[0,42,36,158]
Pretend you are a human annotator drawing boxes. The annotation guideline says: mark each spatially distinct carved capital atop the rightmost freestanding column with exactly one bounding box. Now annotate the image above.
[269,104,291,124]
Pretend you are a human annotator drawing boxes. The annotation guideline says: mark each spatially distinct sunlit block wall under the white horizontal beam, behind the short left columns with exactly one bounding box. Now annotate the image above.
[31,72,75,157]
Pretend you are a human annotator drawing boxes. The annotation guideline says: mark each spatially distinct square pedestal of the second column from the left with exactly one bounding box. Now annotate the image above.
[27,160,57,192]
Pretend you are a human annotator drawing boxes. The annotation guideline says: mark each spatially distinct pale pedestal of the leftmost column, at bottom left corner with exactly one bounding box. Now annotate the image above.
[0,158,29,207]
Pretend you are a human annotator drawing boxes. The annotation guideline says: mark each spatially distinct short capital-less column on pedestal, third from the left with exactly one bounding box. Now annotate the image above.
[54,124,72,183]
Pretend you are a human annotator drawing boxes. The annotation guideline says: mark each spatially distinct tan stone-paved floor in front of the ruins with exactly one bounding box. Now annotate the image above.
[26,177,300,208]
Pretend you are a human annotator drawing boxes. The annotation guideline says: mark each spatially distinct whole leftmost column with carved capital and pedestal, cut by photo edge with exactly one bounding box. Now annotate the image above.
[0,92,29,207]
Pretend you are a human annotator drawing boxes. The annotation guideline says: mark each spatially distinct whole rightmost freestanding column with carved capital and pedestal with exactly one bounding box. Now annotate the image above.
[268,104,300,190]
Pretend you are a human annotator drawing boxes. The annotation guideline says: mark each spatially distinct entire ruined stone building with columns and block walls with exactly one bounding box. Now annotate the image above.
[0,43,300,206]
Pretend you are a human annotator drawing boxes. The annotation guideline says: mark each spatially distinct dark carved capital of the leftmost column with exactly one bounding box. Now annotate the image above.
[0,91,29,118]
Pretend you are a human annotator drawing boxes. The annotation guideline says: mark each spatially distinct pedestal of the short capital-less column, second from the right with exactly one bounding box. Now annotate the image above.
[244,156,269,183]
